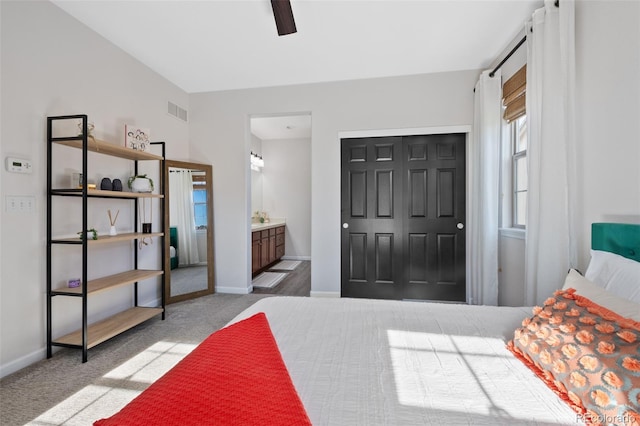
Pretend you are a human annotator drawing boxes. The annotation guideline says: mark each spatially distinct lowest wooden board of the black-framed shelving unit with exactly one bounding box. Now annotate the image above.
[53,306,163,349]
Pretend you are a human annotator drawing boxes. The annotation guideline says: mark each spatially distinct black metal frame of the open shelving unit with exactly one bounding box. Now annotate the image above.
[46,114,166,363]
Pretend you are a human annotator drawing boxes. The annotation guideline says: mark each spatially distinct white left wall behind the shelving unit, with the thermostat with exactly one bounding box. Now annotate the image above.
[0,1,189,375]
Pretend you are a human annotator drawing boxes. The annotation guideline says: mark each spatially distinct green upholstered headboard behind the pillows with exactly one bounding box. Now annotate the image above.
[591,223,640,262]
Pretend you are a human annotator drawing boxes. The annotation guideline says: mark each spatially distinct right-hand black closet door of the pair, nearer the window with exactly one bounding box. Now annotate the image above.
[402,134,466,302]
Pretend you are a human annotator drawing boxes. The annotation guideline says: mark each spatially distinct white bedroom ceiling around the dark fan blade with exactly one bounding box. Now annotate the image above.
[52,0,542,93]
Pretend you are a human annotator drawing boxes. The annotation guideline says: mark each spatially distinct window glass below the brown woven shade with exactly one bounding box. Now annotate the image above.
[510,115,529,228]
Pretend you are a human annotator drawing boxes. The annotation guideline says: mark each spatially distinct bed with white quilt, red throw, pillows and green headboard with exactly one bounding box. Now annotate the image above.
[97,224,640,425]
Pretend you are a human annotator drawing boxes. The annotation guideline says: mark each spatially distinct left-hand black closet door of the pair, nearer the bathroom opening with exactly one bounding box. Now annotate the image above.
[341,137,403,299]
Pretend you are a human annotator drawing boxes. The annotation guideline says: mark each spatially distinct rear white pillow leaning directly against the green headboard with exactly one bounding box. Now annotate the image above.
[584,250,640,303]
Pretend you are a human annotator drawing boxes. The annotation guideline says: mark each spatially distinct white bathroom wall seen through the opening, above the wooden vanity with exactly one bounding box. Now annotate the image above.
[262,139,311,260]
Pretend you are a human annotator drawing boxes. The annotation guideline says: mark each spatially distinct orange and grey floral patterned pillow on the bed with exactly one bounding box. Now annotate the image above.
[507,289,640,425]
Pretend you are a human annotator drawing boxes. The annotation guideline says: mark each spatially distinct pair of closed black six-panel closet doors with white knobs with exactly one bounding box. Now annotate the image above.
[341,134,466,301]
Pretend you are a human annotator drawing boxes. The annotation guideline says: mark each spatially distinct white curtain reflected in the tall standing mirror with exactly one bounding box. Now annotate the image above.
[169,169,200,265]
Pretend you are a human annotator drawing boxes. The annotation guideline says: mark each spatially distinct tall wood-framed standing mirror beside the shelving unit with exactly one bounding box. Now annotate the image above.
[164,160,214,304]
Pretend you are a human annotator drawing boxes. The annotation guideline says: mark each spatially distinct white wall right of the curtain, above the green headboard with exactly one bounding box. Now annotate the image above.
[576,1,640,266]
